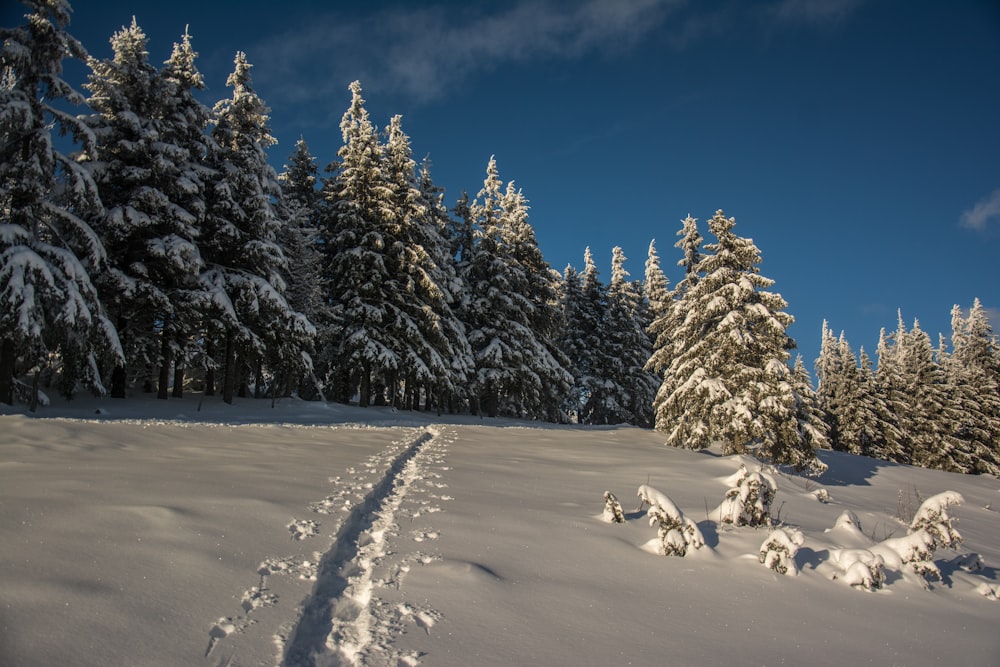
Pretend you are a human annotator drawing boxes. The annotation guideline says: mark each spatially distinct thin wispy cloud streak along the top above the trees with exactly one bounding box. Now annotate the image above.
[248,0,683,107]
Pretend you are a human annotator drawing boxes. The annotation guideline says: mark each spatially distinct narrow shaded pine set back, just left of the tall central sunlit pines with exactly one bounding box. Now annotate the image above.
[277,139,330,398]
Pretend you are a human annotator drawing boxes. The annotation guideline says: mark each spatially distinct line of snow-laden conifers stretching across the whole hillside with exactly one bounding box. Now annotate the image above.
[0,0,1000,474]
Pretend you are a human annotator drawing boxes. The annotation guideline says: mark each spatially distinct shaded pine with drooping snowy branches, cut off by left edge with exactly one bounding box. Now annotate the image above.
[0,0,123,404]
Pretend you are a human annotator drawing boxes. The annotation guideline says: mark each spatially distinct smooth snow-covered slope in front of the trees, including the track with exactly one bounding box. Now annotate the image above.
[0,397,1000,667]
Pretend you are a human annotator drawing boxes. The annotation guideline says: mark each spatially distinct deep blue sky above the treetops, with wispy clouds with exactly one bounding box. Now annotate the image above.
[2,0,1000,369]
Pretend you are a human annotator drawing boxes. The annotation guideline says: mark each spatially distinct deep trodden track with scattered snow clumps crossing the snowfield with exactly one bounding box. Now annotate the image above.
[205,426,454,667]
